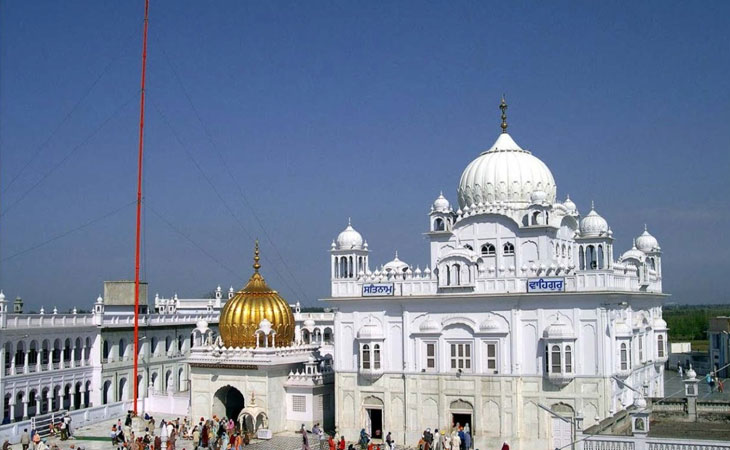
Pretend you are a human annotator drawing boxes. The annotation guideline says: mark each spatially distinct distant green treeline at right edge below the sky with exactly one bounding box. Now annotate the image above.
[663,305,730,341]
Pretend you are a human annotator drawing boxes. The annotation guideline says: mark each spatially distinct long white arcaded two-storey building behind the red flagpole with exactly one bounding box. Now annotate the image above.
[0,280,221,423]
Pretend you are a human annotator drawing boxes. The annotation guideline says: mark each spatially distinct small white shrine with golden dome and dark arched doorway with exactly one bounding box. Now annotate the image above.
[187,242,334,438]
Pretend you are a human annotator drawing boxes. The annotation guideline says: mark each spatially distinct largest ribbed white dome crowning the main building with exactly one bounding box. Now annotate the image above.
[459,133,556,209]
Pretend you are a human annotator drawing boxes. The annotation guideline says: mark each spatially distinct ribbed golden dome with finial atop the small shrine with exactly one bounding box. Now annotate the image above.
[218,241,294,348]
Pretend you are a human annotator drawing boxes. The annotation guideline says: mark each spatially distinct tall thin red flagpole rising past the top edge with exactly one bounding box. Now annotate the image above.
[134,0,150,416]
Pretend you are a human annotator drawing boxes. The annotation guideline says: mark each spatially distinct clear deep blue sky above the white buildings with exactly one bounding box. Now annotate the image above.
[0,0,730,310]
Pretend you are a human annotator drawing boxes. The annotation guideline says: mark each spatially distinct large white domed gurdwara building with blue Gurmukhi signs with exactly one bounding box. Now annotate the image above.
[326,99,668,449]
